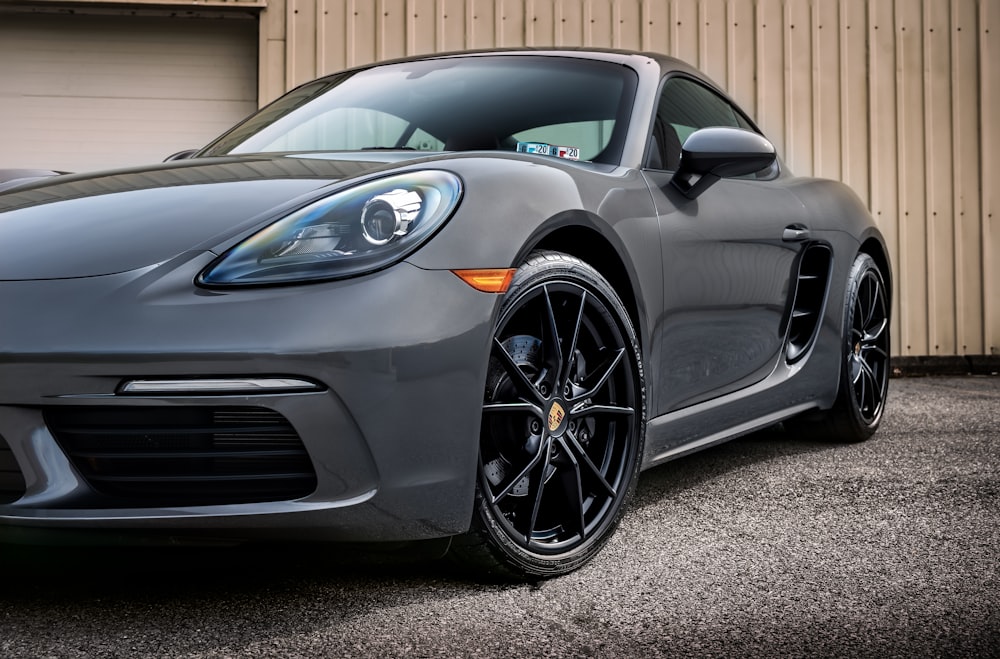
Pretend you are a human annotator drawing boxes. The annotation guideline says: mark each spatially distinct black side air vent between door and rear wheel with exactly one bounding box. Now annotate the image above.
[785,243,833,363]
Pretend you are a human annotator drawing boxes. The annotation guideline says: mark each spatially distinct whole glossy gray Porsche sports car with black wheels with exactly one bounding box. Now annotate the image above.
[0,50,892,578]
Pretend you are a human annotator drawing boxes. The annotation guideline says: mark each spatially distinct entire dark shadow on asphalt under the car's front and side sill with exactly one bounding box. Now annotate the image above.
[0,428,872,653]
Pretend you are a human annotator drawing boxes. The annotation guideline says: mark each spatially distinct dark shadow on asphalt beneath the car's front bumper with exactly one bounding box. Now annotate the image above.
[0,543,485,656]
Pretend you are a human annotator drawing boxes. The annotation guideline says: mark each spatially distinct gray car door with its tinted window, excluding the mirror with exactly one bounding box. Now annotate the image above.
[643,77,803,414]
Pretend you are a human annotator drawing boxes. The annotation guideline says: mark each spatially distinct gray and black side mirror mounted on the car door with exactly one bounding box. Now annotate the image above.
[670,126,777,199]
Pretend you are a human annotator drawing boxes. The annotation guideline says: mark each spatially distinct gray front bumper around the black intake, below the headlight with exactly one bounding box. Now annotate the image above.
[0,254,497,541]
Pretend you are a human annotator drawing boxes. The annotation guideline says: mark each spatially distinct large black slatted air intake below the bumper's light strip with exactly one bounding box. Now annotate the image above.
[45,407,316,507]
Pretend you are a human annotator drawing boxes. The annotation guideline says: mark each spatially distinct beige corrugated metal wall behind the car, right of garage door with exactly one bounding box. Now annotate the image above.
[261,0,1000,355]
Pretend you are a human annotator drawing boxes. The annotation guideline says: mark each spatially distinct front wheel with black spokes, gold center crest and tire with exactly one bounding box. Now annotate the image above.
[452,252,645,580]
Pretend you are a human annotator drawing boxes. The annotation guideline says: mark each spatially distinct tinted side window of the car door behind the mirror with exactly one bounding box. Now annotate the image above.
[649,78,753,170]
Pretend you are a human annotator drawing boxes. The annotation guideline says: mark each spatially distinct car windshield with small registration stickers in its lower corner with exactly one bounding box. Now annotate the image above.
[200,55,637,163]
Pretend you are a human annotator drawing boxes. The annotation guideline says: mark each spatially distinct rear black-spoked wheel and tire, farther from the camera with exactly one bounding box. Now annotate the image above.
[785,254,890,442]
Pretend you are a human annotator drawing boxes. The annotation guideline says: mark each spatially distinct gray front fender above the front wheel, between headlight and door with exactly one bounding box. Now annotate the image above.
[398,154,663,410]
